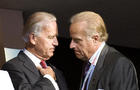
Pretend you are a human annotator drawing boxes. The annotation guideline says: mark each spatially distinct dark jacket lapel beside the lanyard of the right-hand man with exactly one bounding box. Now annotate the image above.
[88,45,109,90]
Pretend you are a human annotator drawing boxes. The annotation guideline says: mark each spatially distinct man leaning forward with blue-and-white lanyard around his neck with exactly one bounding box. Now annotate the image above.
[70,11,138,90]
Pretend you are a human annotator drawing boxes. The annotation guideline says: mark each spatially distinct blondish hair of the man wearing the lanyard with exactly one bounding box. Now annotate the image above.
[70,11,108,41]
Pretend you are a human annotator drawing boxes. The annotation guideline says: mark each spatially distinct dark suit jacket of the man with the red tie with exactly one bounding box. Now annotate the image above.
[2,51,67,90]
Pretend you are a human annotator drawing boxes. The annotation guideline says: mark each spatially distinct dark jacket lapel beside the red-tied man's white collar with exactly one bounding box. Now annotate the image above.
[18,51,40,75]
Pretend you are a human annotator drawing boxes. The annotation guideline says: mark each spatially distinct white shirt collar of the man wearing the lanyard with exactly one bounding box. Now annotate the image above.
[89,42,105,66]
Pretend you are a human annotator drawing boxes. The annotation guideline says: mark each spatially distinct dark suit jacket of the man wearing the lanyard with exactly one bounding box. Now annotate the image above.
[80,45,139,90]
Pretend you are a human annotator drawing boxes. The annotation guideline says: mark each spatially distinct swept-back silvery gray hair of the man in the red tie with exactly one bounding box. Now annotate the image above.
[22,12,56,43]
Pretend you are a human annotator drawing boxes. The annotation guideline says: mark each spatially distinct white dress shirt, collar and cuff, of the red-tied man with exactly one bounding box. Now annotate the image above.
[23,49,59,90]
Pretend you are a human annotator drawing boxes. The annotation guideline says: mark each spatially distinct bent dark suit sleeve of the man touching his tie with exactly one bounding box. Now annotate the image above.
[2,63,55,90]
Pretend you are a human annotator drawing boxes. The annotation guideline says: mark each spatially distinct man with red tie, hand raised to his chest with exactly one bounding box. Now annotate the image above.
[2,12,67,90]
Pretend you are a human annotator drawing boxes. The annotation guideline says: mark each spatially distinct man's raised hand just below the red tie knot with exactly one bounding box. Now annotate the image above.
[37,66,56,80]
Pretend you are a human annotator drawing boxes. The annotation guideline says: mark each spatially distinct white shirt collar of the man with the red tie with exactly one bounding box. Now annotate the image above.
[23,48,41,66]
